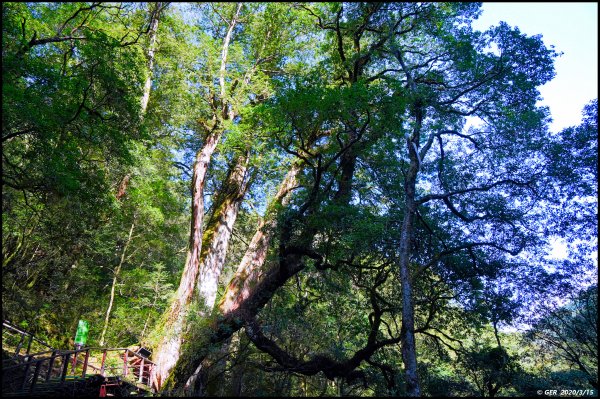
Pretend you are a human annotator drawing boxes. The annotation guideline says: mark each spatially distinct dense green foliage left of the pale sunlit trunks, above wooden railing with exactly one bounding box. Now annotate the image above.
[2,3,185,354]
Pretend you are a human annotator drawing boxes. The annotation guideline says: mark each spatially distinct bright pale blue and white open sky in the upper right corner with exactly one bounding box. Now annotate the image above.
[473,2,598,131]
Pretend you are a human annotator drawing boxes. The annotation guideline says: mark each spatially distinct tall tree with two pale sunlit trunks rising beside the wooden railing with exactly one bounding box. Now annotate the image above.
[152,3,314,388]
